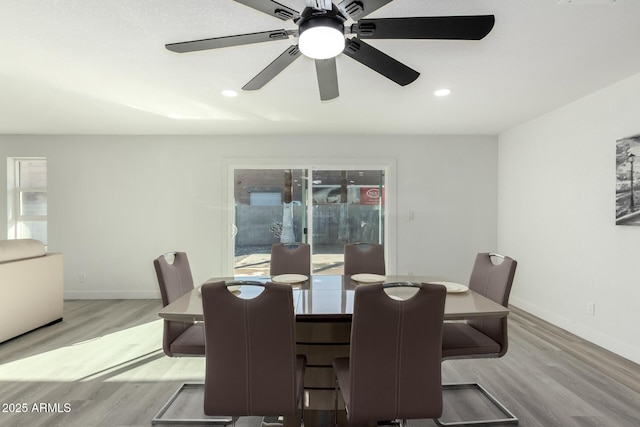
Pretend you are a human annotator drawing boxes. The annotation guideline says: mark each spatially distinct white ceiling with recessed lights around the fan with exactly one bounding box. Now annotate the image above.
[0,0,640,135]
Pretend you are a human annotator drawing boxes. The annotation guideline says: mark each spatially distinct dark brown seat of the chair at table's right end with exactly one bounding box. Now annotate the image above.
[442,323,500,359]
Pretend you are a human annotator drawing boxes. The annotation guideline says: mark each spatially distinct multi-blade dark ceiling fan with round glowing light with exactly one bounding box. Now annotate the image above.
[165,0,495,101]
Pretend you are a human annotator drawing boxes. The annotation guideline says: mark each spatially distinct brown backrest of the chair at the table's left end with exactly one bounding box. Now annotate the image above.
[153,252,193,356]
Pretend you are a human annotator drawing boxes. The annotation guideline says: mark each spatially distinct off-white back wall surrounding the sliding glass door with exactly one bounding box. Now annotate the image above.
[0,135,497,298]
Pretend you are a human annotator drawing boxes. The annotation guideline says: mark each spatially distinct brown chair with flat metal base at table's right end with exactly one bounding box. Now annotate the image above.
[436,253,518,426]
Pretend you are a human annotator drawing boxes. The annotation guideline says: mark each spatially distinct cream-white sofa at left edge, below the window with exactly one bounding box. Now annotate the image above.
[0,239,64,343]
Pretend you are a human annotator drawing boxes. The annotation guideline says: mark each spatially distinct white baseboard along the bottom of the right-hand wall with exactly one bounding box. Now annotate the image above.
[509,296,640,364]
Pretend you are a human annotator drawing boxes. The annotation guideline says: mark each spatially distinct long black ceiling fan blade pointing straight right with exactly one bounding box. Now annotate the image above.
[351,15,495,40]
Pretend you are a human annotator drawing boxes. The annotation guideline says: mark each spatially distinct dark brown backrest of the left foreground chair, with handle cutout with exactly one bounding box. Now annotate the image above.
[202,282,299,416]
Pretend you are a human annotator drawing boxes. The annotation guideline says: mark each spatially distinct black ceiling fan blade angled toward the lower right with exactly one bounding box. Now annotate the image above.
[342,38,420,86]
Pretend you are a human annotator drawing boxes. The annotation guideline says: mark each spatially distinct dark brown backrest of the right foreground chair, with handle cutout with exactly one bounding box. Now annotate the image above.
[347,284,446,422]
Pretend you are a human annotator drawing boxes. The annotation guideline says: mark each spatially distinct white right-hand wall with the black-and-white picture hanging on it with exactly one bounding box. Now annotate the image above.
[498,74,640,363]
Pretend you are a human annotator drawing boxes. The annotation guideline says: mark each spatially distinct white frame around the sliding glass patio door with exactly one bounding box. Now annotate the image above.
[220,157,397,276]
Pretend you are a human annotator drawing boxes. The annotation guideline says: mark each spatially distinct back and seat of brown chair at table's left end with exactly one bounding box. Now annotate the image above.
[153,252,204,356]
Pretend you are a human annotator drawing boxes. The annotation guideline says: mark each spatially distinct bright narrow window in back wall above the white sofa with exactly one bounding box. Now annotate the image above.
[7,158,47,245]
